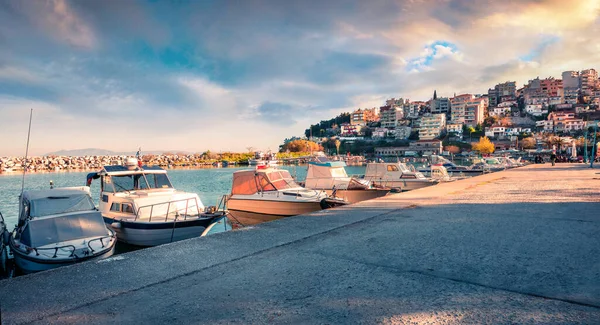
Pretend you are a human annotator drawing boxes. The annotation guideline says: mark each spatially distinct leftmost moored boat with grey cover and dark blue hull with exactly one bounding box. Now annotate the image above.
[8,187,117,273]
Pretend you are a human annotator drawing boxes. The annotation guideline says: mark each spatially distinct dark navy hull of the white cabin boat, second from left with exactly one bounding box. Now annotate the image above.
[104,215,221,247]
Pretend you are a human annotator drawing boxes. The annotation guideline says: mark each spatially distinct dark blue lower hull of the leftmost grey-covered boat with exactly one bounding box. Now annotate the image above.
[10,240,116,274]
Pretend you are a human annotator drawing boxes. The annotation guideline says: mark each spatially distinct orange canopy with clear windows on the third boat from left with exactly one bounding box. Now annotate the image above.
[231,168,300,195]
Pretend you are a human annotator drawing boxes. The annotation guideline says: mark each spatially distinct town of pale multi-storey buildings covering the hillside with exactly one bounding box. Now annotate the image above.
[302,69,600,156]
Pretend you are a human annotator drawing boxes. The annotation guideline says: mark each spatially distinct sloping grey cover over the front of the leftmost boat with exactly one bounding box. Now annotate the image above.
[20,212,110,247]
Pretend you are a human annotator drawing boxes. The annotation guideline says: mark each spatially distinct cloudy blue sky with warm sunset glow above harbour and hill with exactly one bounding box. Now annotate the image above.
[0,0,600,156]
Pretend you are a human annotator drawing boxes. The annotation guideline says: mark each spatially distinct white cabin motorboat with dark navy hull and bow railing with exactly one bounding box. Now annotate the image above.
[87,158,226,246]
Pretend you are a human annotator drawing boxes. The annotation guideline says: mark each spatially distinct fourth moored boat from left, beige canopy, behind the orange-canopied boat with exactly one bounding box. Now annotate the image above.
[304,161,390,203]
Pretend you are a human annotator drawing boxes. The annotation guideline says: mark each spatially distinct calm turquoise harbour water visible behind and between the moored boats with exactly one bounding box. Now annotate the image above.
[0,166,365,227]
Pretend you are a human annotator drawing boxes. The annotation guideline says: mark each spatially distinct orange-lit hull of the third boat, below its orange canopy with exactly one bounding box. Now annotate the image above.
[227,198,322,226]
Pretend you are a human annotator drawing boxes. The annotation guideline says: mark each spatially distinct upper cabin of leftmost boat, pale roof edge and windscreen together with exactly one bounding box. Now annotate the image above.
[20,187,96,219]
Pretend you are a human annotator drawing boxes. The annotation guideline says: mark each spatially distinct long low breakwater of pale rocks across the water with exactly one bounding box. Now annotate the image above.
[0,154,236,173]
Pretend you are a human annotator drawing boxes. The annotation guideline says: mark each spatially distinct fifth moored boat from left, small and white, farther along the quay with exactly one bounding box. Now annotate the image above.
[365,162,439,191]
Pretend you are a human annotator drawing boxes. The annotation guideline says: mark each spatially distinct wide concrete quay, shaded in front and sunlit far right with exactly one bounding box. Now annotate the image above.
[0,164,600,324]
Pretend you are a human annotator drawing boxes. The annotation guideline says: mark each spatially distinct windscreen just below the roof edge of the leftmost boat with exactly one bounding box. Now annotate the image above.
[29,194,96,218]
